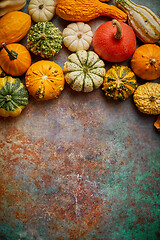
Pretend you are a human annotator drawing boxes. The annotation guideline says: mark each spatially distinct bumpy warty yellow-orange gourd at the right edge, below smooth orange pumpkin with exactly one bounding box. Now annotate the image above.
[133,82,160,115]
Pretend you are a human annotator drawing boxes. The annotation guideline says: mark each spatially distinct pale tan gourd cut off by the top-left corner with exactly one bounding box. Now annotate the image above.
[0,0,26,17]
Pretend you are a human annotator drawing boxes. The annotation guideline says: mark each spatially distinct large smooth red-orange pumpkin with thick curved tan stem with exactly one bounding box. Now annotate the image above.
[92,19,136,62]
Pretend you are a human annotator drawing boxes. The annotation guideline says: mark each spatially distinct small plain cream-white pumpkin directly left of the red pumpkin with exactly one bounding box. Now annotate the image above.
[62,22,93,52]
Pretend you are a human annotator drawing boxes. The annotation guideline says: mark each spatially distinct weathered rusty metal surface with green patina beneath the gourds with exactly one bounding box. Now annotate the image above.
[0,0,160,240]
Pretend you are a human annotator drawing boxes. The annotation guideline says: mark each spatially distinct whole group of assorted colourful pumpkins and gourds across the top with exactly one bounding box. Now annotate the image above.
[0,0,160,129]
